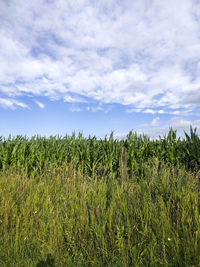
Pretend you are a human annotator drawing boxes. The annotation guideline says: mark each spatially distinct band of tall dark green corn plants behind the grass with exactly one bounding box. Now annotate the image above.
[0,128,200,177]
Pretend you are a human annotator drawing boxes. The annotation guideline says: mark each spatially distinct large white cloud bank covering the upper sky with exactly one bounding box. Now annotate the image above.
[0,0,200,115]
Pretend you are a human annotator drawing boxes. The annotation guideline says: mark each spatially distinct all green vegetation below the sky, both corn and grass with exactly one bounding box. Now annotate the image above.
[0,128,200,267]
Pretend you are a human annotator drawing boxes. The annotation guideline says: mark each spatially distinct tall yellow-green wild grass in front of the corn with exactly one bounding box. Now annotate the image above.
[0,159,200,266]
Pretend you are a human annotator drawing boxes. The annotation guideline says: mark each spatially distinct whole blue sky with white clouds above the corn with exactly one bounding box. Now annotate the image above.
[0,0,200,138]
